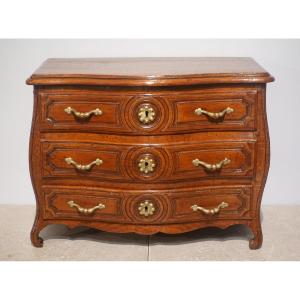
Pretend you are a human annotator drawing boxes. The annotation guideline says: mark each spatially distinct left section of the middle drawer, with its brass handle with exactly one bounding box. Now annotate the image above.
[42,141,129,180]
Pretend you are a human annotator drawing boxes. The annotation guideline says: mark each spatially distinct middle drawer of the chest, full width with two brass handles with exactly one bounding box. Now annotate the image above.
[42,141,255,184]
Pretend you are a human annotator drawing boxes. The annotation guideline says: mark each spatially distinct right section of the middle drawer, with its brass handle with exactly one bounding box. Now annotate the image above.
[169,141,255,179]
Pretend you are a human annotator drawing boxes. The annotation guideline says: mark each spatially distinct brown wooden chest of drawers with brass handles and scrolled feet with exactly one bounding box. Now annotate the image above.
[27,58,273,249]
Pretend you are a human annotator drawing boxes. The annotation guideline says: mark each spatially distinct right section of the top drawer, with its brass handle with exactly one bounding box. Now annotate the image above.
[168,88,257,132]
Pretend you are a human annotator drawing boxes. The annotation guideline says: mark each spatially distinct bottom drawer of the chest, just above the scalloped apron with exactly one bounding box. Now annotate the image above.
[44,186,252,224]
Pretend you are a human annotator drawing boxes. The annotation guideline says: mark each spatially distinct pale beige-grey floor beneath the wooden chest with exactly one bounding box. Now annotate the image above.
[0,205,300,260]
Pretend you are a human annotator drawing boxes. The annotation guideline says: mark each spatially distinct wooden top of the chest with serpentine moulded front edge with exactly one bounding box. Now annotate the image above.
[27,57,274,86]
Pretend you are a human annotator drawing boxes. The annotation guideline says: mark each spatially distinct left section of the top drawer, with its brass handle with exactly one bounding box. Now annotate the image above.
[39,90,126,132]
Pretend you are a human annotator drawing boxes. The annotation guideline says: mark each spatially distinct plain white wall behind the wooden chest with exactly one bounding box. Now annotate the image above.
[0,40,300,204]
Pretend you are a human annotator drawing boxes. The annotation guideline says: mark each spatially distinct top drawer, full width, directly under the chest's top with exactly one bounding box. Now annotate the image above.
[39,87,257,135]
